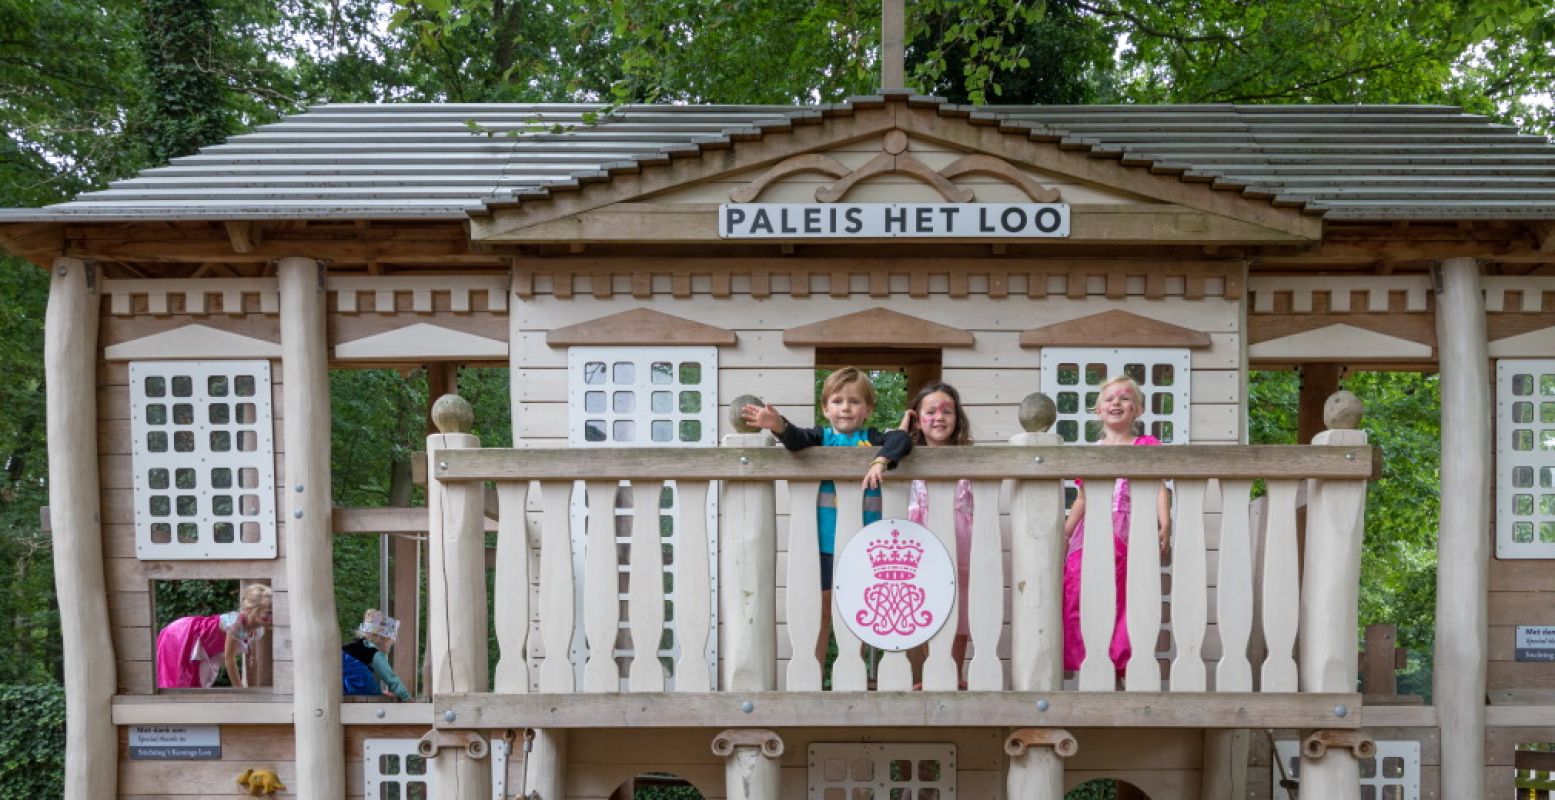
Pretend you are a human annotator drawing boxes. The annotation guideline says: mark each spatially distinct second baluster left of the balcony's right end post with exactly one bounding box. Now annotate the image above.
[1214,479,1253,691]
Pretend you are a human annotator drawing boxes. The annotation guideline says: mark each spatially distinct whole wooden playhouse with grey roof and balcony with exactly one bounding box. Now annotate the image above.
[0,92,1555,800]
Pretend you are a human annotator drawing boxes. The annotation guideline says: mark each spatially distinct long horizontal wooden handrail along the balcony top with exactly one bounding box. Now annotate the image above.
[432,445,1382,482]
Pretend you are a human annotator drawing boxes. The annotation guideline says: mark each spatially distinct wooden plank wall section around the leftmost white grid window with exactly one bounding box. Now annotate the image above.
[98,310,292,694]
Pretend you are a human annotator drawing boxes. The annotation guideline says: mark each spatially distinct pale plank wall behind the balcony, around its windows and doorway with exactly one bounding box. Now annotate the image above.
[512,266,1242,680]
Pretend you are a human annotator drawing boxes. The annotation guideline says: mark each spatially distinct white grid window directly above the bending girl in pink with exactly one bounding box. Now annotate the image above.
[129,361,275,559]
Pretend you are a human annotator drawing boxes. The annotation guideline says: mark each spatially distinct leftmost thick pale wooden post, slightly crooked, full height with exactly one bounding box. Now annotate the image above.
[44,258,118,800]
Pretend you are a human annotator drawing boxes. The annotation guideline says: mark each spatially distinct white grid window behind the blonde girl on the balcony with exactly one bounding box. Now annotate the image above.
[1042,347,1190,445]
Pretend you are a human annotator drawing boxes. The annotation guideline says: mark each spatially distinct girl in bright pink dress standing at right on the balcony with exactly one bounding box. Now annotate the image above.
[1064,377,1171,674]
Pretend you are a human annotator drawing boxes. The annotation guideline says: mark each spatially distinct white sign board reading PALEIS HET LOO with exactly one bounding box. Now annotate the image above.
[718,202,1070,238]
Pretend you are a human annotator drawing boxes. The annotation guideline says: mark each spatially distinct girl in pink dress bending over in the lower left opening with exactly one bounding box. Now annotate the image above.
[157,584,271,689]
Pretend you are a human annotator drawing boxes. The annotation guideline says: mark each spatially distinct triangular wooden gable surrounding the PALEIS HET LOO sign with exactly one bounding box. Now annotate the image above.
[471,100,1322,244]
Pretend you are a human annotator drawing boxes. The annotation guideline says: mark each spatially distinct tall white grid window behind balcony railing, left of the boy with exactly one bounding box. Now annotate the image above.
[568,347,718,689]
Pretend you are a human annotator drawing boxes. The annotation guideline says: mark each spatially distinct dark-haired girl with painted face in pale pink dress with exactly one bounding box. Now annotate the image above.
[902,381,972,672]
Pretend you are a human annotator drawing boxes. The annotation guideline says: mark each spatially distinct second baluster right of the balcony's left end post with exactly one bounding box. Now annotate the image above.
[540,481,577,693]
